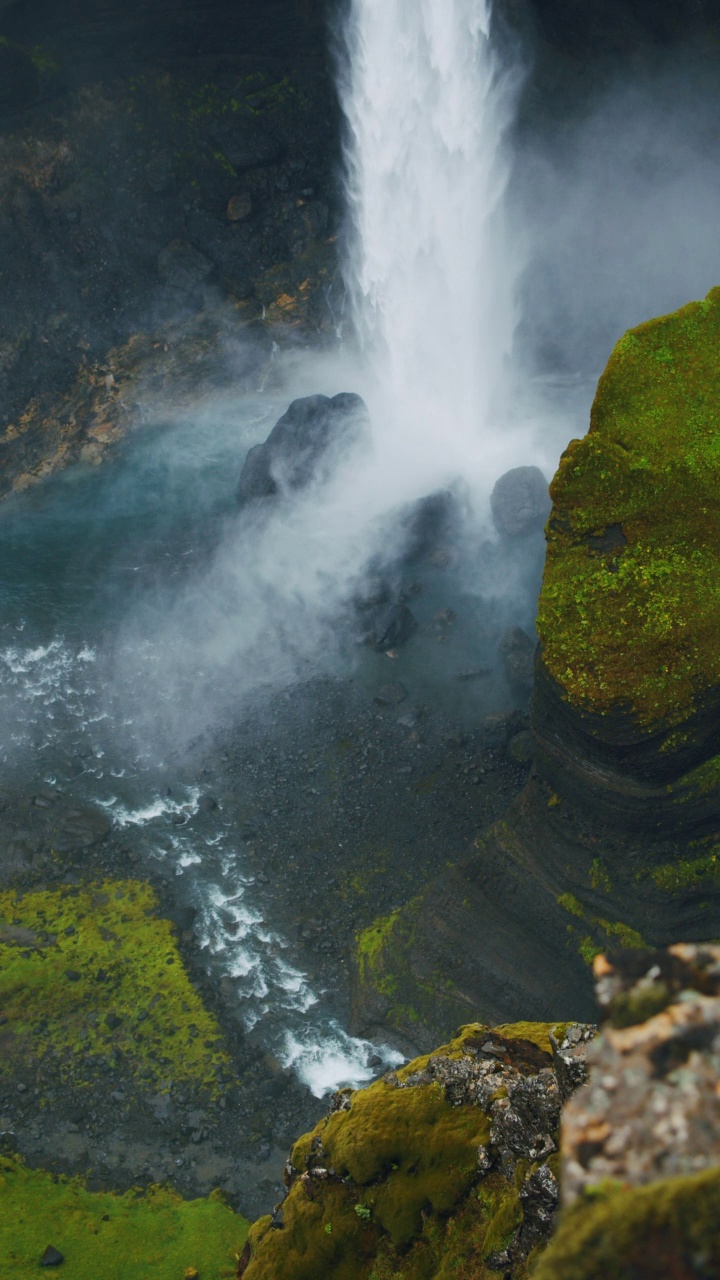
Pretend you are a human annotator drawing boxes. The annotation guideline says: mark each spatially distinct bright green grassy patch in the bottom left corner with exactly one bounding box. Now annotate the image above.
[0,1156,249,1280]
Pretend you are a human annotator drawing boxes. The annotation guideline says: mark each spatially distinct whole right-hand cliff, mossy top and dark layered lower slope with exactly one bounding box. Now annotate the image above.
[354,289,720,1046]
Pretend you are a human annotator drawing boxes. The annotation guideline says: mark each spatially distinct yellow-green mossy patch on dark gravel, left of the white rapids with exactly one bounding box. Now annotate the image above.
[0,881,229,1092]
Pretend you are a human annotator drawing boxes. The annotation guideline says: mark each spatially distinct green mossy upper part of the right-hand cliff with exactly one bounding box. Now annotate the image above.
[538,289,720,733]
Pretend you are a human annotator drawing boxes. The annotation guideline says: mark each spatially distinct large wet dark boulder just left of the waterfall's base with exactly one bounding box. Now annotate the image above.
[238,392,369,503]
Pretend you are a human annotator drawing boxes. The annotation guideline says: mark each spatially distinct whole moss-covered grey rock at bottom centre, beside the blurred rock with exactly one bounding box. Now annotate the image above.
[241,1023,588,1280]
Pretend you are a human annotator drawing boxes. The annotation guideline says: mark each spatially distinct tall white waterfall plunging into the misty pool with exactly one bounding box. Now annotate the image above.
[338,0,520,494]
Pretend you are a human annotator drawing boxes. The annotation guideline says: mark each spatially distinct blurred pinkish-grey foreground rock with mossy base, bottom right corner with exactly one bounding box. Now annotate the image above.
[534,945,720,1280]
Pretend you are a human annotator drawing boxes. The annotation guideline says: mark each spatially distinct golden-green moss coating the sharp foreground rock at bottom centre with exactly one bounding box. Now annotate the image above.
[245,1023,561,1280]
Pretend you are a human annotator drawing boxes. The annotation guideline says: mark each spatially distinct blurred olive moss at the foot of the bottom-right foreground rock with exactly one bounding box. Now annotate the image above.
[533,1170,720,1280]
